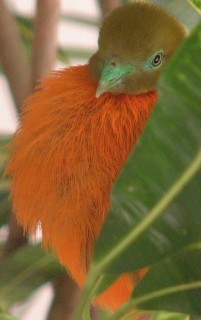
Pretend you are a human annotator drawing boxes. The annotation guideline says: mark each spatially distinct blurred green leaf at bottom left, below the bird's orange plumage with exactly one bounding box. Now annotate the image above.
[0,244,63,310]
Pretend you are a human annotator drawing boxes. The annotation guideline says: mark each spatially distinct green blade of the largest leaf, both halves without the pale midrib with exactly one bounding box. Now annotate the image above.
[94,21,201,272]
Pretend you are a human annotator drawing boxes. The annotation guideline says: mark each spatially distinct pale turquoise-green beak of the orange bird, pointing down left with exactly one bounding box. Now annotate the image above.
[96,61,134,98]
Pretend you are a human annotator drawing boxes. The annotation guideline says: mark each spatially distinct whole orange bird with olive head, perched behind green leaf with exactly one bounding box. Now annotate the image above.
[6,1,186,311]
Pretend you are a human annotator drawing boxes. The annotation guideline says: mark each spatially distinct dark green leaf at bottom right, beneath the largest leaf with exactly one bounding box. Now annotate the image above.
[133,243,201,314]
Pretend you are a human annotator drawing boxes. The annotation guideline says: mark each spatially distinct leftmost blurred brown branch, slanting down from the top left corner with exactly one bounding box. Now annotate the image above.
[0,0,31,111]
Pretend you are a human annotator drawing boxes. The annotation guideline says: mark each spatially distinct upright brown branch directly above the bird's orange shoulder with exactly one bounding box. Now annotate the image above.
[32,0,60,85]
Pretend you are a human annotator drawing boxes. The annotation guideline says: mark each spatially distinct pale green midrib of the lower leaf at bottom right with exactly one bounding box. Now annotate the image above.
[109,281,201,320]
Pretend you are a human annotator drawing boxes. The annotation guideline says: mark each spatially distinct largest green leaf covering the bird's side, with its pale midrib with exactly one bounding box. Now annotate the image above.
[74,20,201,319]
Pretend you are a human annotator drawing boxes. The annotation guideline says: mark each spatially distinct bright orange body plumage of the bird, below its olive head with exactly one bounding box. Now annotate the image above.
[7,0,185,310]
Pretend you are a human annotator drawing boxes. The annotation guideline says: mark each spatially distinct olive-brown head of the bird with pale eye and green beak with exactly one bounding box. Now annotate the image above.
[89,1,185,97]
